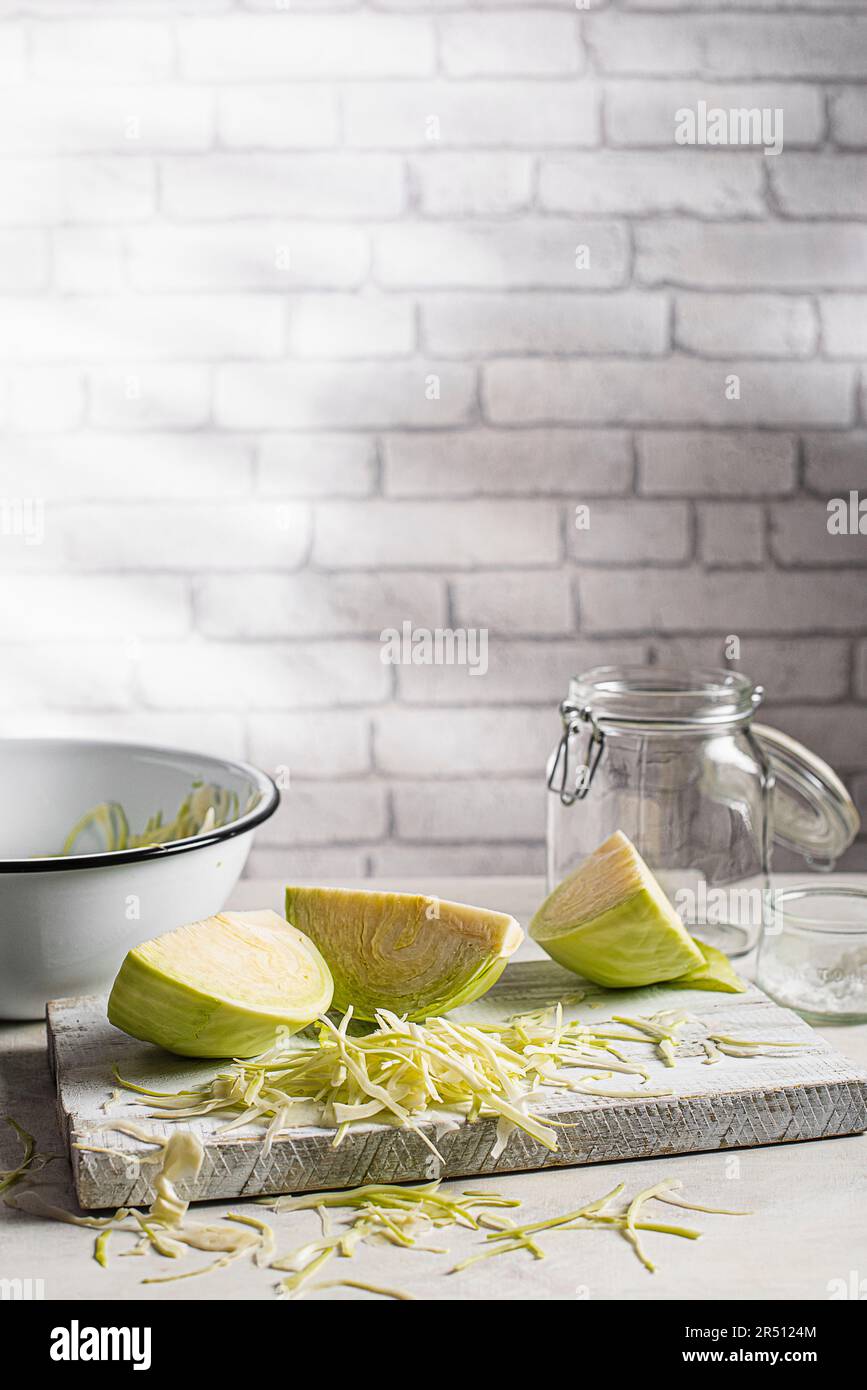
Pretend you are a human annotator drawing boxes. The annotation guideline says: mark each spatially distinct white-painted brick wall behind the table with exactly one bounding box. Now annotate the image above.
[0,0,867,876]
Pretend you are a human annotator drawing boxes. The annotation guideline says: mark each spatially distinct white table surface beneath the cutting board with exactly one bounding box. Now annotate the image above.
[0,874,867,1302]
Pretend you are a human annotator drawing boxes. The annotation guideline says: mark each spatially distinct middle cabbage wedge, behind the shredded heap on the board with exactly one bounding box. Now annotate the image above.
[286,888,524,1022]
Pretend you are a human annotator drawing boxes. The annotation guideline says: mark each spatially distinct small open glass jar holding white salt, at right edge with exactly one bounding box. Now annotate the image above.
[757,884,867,1023]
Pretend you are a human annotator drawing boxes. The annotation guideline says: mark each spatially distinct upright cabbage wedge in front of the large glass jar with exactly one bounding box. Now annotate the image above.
[529,830,706,990]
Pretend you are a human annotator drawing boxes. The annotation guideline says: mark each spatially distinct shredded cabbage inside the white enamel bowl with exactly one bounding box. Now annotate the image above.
[60,783,254,858]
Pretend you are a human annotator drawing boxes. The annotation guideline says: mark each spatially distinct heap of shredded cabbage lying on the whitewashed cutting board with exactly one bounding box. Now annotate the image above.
[117,1005,792,1161]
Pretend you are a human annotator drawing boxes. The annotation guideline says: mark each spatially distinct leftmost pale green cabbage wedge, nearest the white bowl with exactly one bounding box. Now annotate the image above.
[108,910,332,1056]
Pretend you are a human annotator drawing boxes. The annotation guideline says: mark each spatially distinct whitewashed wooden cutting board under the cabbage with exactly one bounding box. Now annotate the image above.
[47,962,867,1208]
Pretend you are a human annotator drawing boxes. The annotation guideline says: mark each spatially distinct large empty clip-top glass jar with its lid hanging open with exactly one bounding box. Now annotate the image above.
[547,666,859,955]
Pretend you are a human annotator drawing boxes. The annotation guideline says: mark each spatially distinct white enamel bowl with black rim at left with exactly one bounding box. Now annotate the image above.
[0,738,279,1019]
